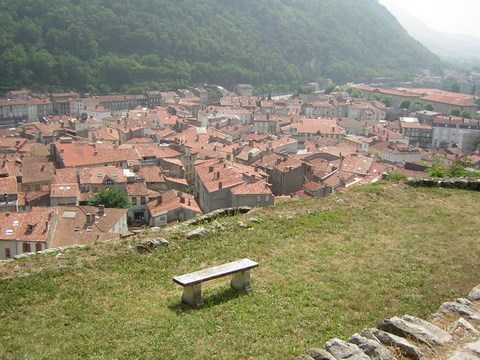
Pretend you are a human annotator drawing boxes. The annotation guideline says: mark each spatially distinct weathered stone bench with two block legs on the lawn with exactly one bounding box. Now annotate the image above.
[173,259,258,307]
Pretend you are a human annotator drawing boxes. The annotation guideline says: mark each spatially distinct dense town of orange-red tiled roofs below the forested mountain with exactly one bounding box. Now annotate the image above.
[0,84,480,260]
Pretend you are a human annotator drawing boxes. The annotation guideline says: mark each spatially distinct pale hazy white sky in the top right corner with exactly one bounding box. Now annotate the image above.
[379,0,480,37]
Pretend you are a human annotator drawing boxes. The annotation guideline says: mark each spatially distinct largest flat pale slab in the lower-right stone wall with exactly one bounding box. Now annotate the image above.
[378,315,452,345]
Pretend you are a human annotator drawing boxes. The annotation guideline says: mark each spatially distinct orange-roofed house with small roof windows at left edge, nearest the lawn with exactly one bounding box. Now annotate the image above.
[0,208,57,260]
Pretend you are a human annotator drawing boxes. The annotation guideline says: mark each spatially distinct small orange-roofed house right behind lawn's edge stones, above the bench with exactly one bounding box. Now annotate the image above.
[147,190,202,226]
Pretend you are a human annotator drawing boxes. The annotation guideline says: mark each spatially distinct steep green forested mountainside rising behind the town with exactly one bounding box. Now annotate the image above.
[0,0,441,93]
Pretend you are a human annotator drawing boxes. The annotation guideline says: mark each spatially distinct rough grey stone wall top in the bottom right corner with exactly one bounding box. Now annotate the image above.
[298,285,480,360]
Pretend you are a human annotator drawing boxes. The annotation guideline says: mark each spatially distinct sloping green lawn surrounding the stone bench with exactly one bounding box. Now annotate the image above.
[0,184,480,359]
